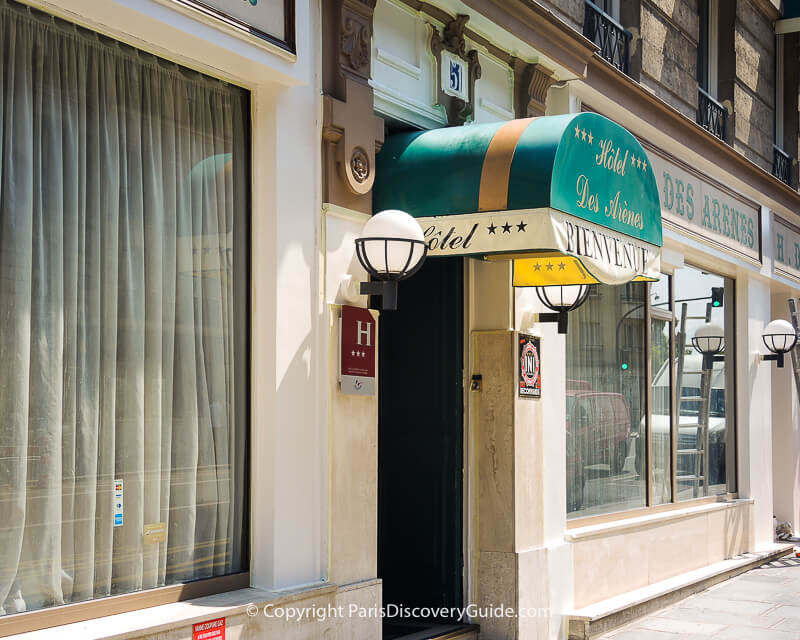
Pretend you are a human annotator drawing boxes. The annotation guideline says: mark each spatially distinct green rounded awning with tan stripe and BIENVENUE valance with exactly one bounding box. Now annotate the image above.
[373,113,662,285]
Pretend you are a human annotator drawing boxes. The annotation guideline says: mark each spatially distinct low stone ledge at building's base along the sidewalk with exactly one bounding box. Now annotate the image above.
[564,544,793,640]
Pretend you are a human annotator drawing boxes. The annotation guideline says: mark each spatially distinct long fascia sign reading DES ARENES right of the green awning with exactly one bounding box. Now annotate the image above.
[647,149,761,262]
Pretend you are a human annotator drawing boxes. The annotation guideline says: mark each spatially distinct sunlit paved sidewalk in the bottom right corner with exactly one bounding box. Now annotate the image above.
[598,556,800,640]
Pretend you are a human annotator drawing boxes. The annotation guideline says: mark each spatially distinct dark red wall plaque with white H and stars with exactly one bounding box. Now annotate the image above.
[339,305,378,396]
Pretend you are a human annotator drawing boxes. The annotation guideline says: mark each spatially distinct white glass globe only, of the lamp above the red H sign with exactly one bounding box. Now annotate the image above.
[360,209,425,279]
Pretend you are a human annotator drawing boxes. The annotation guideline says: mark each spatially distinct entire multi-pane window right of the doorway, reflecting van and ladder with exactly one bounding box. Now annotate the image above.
[566,266,736,518]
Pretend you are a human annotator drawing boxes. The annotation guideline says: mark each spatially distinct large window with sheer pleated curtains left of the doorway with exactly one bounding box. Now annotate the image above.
[0,1,250,615]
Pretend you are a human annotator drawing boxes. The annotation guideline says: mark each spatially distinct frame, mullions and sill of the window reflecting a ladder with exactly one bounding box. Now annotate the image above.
[566,262,739,530]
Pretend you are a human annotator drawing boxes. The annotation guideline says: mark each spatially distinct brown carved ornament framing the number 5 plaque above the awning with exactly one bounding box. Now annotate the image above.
[430,15,481,126]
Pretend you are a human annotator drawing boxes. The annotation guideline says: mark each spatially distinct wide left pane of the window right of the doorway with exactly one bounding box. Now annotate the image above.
[567,283,648,517]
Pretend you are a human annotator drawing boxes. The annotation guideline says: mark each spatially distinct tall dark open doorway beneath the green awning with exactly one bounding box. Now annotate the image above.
[378,258,464,638]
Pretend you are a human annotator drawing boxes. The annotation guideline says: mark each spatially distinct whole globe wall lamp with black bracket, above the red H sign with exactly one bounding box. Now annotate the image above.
[356,209,428,311]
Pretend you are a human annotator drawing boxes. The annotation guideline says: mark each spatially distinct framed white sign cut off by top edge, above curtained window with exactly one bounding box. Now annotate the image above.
[175,0,294,53]
